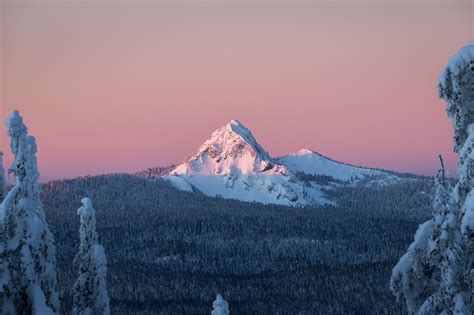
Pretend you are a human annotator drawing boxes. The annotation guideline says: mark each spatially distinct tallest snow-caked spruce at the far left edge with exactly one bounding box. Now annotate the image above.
[0,111,60,315]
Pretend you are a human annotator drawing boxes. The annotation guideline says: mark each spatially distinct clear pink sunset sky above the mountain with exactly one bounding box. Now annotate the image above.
[0,0,474,180]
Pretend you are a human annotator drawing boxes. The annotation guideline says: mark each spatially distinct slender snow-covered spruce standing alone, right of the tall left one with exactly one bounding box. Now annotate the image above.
[73,198,110,315]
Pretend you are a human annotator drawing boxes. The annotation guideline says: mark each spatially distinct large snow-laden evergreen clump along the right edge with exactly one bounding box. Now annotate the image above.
[390,41,474,314]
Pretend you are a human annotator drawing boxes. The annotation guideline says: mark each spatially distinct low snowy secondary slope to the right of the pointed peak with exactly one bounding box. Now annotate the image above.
[277,149,388,181]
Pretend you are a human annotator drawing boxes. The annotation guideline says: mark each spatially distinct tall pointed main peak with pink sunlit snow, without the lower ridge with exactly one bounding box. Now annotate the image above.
[164,120,329,205]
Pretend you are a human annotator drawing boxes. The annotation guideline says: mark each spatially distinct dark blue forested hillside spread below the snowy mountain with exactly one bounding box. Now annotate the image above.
[42,174,433,314]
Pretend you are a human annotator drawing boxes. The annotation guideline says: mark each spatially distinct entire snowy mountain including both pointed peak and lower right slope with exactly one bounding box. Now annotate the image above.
[157,120,396,206]
